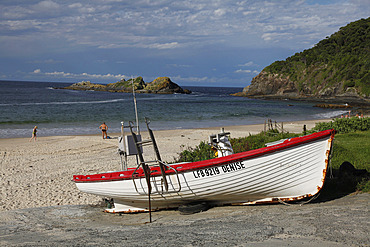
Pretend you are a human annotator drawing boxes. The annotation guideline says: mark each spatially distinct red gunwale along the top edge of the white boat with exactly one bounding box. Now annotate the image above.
[73,129,335,183]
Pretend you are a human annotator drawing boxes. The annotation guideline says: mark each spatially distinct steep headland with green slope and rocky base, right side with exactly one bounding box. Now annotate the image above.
[234,18,370,105]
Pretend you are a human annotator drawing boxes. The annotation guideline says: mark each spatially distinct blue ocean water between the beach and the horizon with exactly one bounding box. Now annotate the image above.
[0,81,343,138]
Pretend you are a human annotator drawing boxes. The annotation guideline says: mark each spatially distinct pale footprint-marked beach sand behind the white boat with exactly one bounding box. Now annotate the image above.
[0,119,331,212]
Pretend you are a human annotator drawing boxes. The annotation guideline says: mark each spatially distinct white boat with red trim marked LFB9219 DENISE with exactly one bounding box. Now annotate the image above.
[73,118,335,213]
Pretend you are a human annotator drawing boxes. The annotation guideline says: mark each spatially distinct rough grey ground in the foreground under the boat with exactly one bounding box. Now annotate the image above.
[0,194,370,247]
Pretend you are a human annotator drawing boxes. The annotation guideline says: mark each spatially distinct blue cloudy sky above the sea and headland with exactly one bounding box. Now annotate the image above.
[0,0,370,87]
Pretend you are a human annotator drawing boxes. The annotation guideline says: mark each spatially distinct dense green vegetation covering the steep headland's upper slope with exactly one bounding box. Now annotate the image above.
[263,17,370,96]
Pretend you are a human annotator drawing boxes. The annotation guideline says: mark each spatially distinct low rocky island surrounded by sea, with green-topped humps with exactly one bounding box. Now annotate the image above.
[57,76,191,94]
